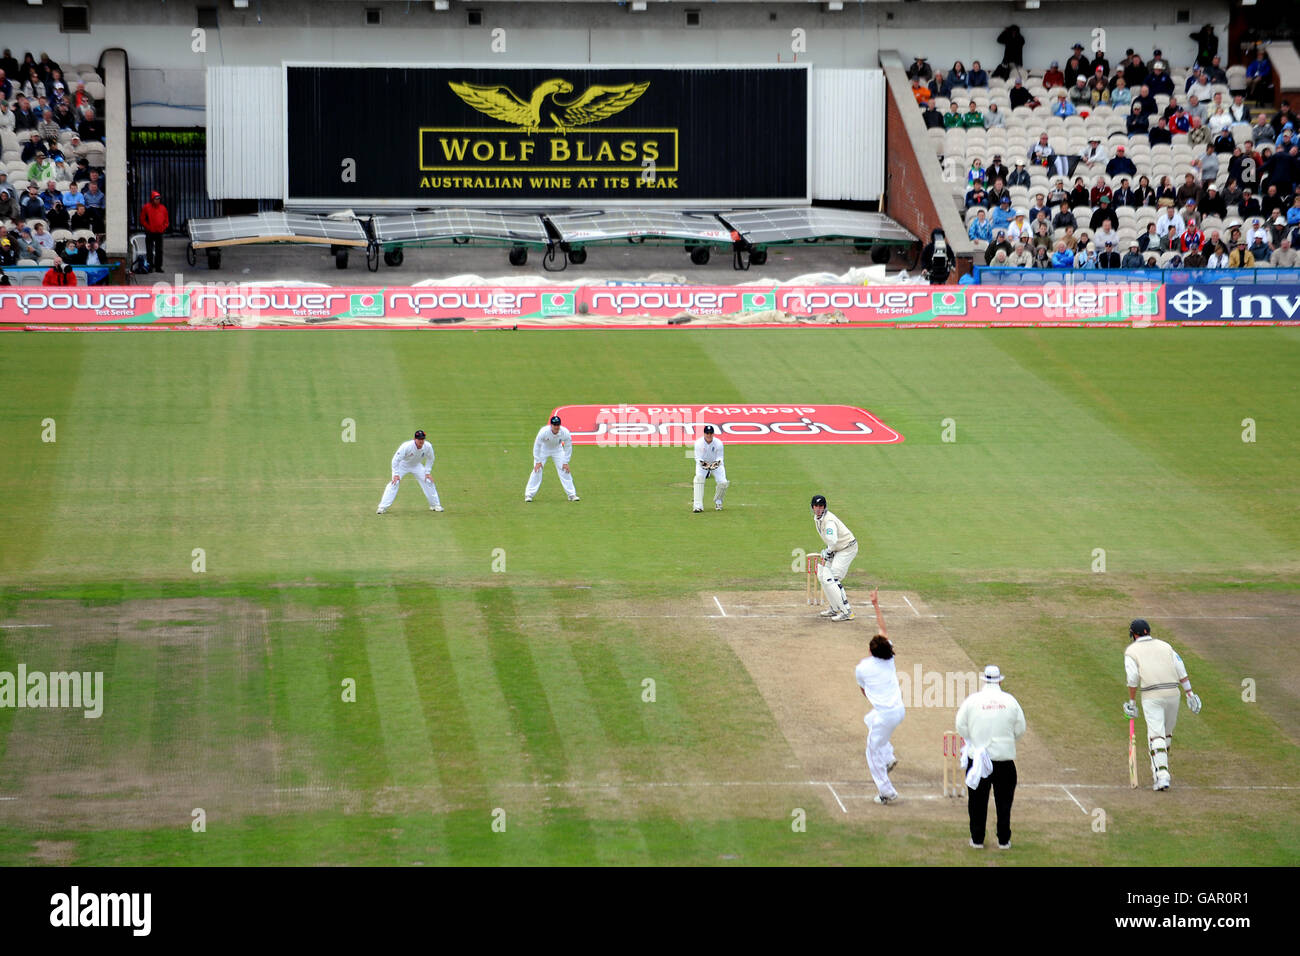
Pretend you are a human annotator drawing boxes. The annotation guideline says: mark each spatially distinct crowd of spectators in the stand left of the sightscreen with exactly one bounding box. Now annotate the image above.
[0,49,105,274]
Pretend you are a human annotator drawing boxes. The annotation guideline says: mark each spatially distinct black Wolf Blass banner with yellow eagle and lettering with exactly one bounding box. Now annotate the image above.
[285,64,810,206]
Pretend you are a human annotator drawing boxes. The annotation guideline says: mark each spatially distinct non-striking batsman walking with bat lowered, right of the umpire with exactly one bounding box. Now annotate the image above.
[1125,618,1201,791]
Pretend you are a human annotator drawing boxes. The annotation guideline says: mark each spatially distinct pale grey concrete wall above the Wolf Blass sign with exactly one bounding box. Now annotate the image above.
[0,0,1229,126]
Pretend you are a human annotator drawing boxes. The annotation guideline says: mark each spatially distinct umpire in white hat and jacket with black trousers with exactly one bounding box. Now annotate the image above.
[957,663,1024,849]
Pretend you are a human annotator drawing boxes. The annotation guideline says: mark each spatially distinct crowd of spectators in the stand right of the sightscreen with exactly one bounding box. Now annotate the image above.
[907,25,1300,269]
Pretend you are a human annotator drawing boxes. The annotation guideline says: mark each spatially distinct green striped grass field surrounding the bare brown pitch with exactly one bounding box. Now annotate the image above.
[0,328,1300,865]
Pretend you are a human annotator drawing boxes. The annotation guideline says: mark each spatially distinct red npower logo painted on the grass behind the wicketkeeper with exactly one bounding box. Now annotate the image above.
[551,405,902,447]
